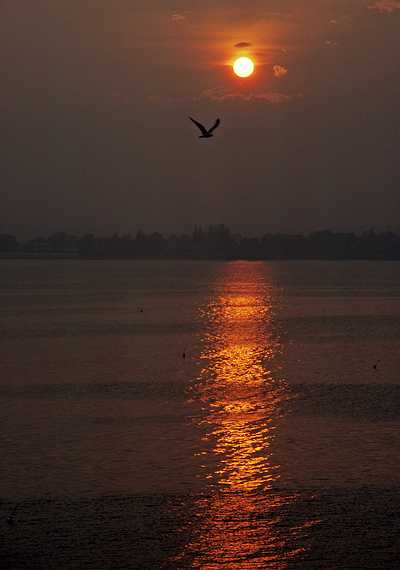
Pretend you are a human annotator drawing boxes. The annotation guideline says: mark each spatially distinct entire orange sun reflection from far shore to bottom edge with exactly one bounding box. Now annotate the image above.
[177,262,314,569]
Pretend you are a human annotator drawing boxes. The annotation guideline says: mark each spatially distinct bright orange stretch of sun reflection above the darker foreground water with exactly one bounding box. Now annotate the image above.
[194,263,285,492]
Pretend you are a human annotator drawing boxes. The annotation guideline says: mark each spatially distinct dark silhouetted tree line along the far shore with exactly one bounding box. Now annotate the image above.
[0,224,400,260]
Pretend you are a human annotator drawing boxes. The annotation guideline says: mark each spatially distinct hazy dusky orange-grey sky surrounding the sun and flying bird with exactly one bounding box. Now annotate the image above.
[0,0,400,236]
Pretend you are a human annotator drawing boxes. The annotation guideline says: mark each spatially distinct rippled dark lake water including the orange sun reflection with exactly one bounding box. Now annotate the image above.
[0,260,400,570]
